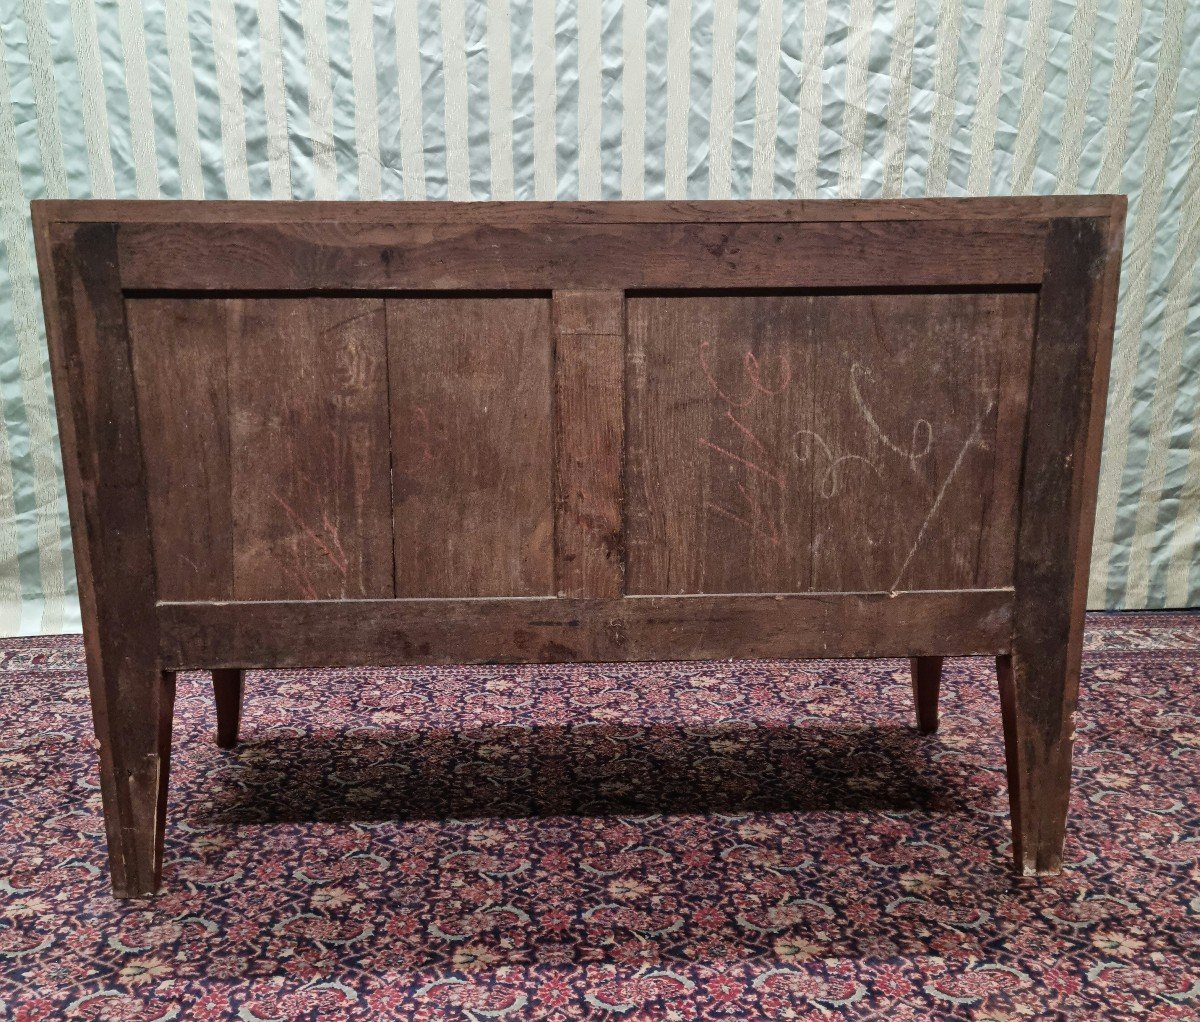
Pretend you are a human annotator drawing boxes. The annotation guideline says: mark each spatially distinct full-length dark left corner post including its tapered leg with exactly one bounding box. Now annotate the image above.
[40,224,175,897]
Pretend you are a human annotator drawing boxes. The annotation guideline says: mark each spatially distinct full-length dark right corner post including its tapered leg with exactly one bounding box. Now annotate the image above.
[997,218,1115,876]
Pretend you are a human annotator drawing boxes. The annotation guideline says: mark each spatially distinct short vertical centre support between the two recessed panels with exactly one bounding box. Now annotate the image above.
[554,290,625,599]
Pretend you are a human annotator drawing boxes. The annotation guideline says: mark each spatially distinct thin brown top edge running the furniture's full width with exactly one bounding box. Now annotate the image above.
[31,194,1124,224]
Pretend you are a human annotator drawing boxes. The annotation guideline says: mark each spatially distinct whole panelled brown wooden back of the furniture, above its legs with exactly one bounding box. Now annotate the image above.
[35,197,1121,667]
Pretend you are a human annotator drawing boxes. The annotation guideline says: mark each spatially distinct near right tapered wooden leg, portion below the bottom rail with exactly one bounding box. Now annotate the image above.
[996,655,1078,877]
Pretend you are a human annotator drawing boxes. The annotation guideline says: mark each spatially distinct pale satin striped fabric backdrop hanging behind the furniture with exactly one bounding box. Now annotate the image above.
[0,0,1200,633]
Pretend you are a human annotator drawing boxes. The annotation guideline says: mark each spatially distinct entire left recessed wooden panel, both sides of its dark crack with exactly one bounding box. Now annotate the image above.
[125,296,553,600]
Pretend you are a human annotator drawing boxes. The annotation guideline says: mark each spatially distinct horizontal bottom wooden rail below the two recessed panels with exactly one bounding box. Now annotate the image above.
[157,589,1013,669]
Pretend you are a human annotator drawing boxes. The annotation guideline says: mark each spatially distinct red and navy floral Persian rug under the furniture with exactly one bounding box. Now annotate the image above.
[0,614,1200,1022]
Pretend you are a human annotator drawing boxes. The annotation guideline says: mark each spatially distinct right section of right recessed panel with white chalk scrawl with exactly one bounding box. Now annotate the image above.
[796,293,1037,591]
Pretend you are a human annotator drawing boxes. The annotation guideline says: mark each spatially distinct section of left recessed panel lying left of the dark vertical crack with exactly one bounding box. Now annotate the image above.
[126,297,394,600]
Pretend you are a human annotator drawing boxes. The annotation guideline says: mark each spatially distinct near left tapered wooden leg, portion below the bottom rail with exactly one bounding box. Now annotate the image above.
[91,665,175,897]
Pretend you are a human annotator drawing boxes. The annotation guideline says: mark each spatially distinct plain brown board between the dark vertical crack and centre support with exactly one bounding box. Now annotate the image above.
[388,297,554,596]
